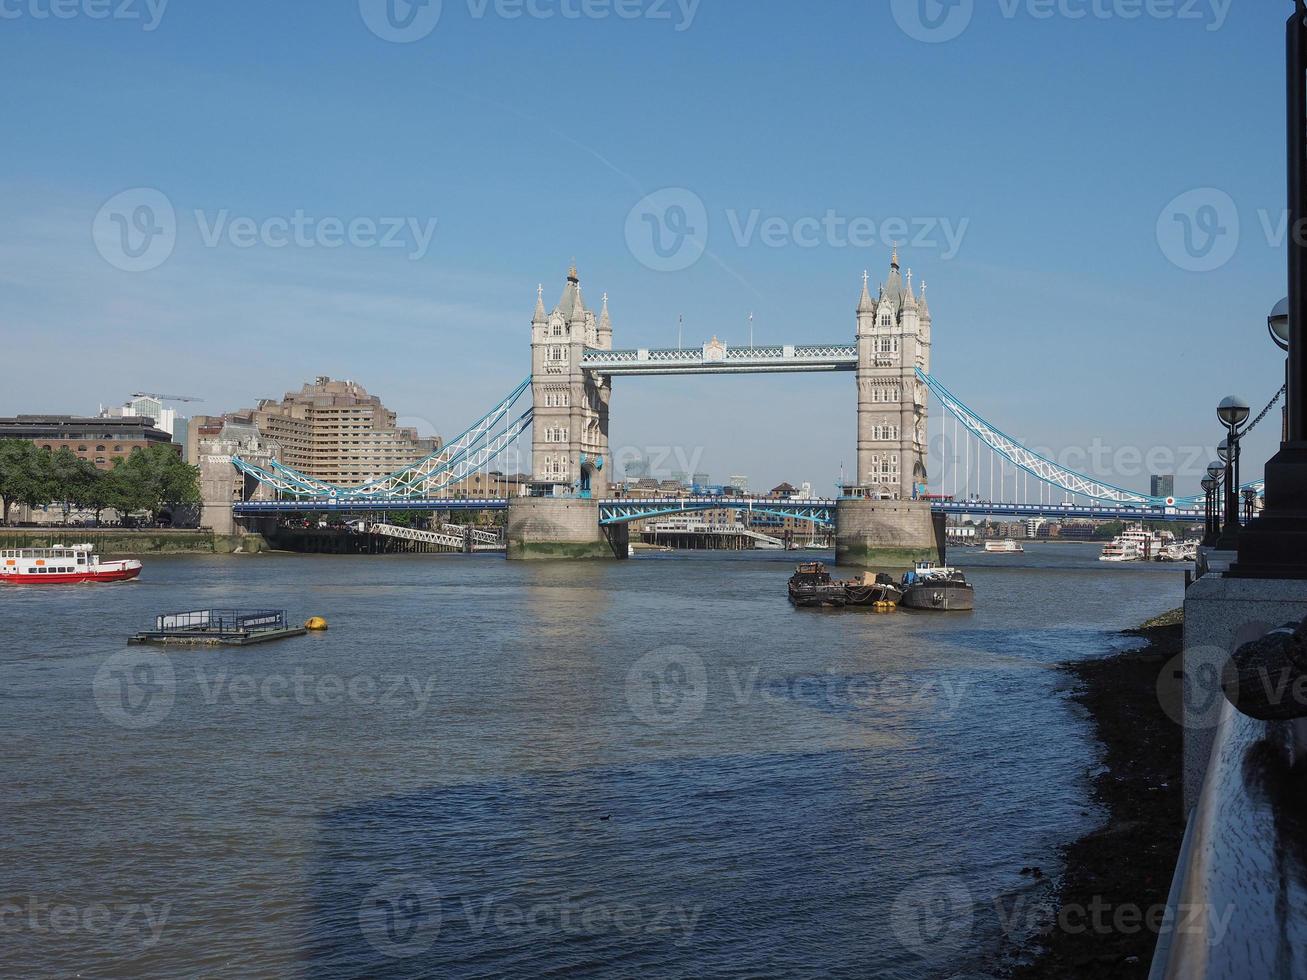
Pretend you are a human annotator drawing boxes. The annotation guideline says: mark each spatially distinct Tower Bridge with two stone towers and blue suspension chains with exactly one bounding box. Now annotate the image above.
[219,250,1228,567]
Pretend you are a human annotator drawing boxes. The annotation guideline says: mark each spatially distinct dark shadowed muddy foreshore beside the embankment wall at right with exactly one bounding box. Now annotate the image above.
[1010,610,1184,980]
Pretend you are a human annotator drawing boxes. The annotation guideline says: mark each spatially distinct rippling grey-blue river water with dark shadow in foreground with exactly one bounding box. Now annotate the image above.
[0,544,1183,977]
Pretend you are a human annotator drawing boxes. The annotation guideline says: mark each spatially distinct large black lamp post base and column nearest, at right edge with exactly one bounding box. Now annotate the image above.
[1226,0,1307,579]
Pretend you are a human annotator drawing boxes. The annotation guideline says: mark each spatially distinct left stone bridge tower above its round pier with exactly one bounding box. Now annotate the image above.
[531,267,613,497]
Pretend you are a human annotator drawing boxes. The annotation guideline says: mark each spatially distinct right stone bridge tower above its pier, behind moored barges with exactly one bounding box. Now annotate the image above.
[857,250,931,500]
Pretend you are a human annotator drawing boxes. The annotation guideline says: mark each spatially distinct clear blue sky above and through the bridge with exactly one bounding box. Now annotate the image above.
[0,0,1291,493]
